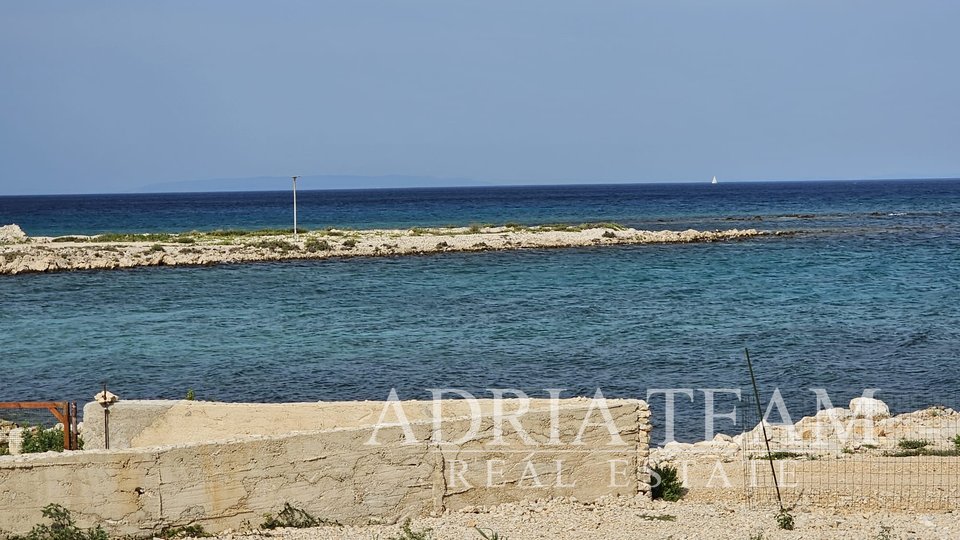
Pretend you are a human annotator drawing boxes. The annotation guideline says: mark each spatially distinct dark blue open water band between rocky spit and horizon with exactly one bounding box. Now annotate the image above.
[7,181,960,236]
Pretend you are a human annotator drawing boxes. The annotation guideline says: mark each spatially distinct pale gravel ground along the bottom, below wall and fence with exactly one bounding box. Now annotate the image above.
[220,498,960,540]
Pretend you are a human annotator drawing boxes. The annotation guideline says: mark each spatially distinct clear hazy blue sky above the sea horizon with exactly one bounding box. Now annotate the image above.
[0,0,960,195]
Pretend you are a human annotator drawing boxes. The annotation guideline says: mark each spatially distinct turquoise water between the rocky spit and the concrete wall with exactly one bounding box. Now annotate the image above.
[0,183,960,439]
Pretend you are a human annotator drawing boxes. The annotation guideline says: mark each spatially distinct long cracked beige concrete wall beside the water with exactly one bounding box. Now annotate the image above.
[0,399,650,534]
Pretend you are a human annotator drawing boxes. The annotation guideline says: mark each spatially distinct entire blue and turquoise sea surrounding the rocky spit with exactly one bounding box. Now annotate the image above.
[0,180,960,443]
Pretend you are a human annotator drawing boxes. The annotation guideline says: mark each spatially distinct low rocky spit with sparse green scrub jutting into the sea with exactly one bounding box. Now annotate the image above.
[0,224,771,275]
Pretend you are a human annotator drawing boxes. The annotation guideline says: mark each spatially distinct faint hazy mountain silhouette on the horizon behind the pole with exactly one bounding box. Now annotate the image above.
[135,175,498,193]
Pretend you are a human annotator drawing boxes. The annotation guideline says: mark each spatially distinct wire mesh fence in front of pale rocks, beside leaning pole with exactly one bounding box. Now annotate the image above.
[741,390,960,510]
